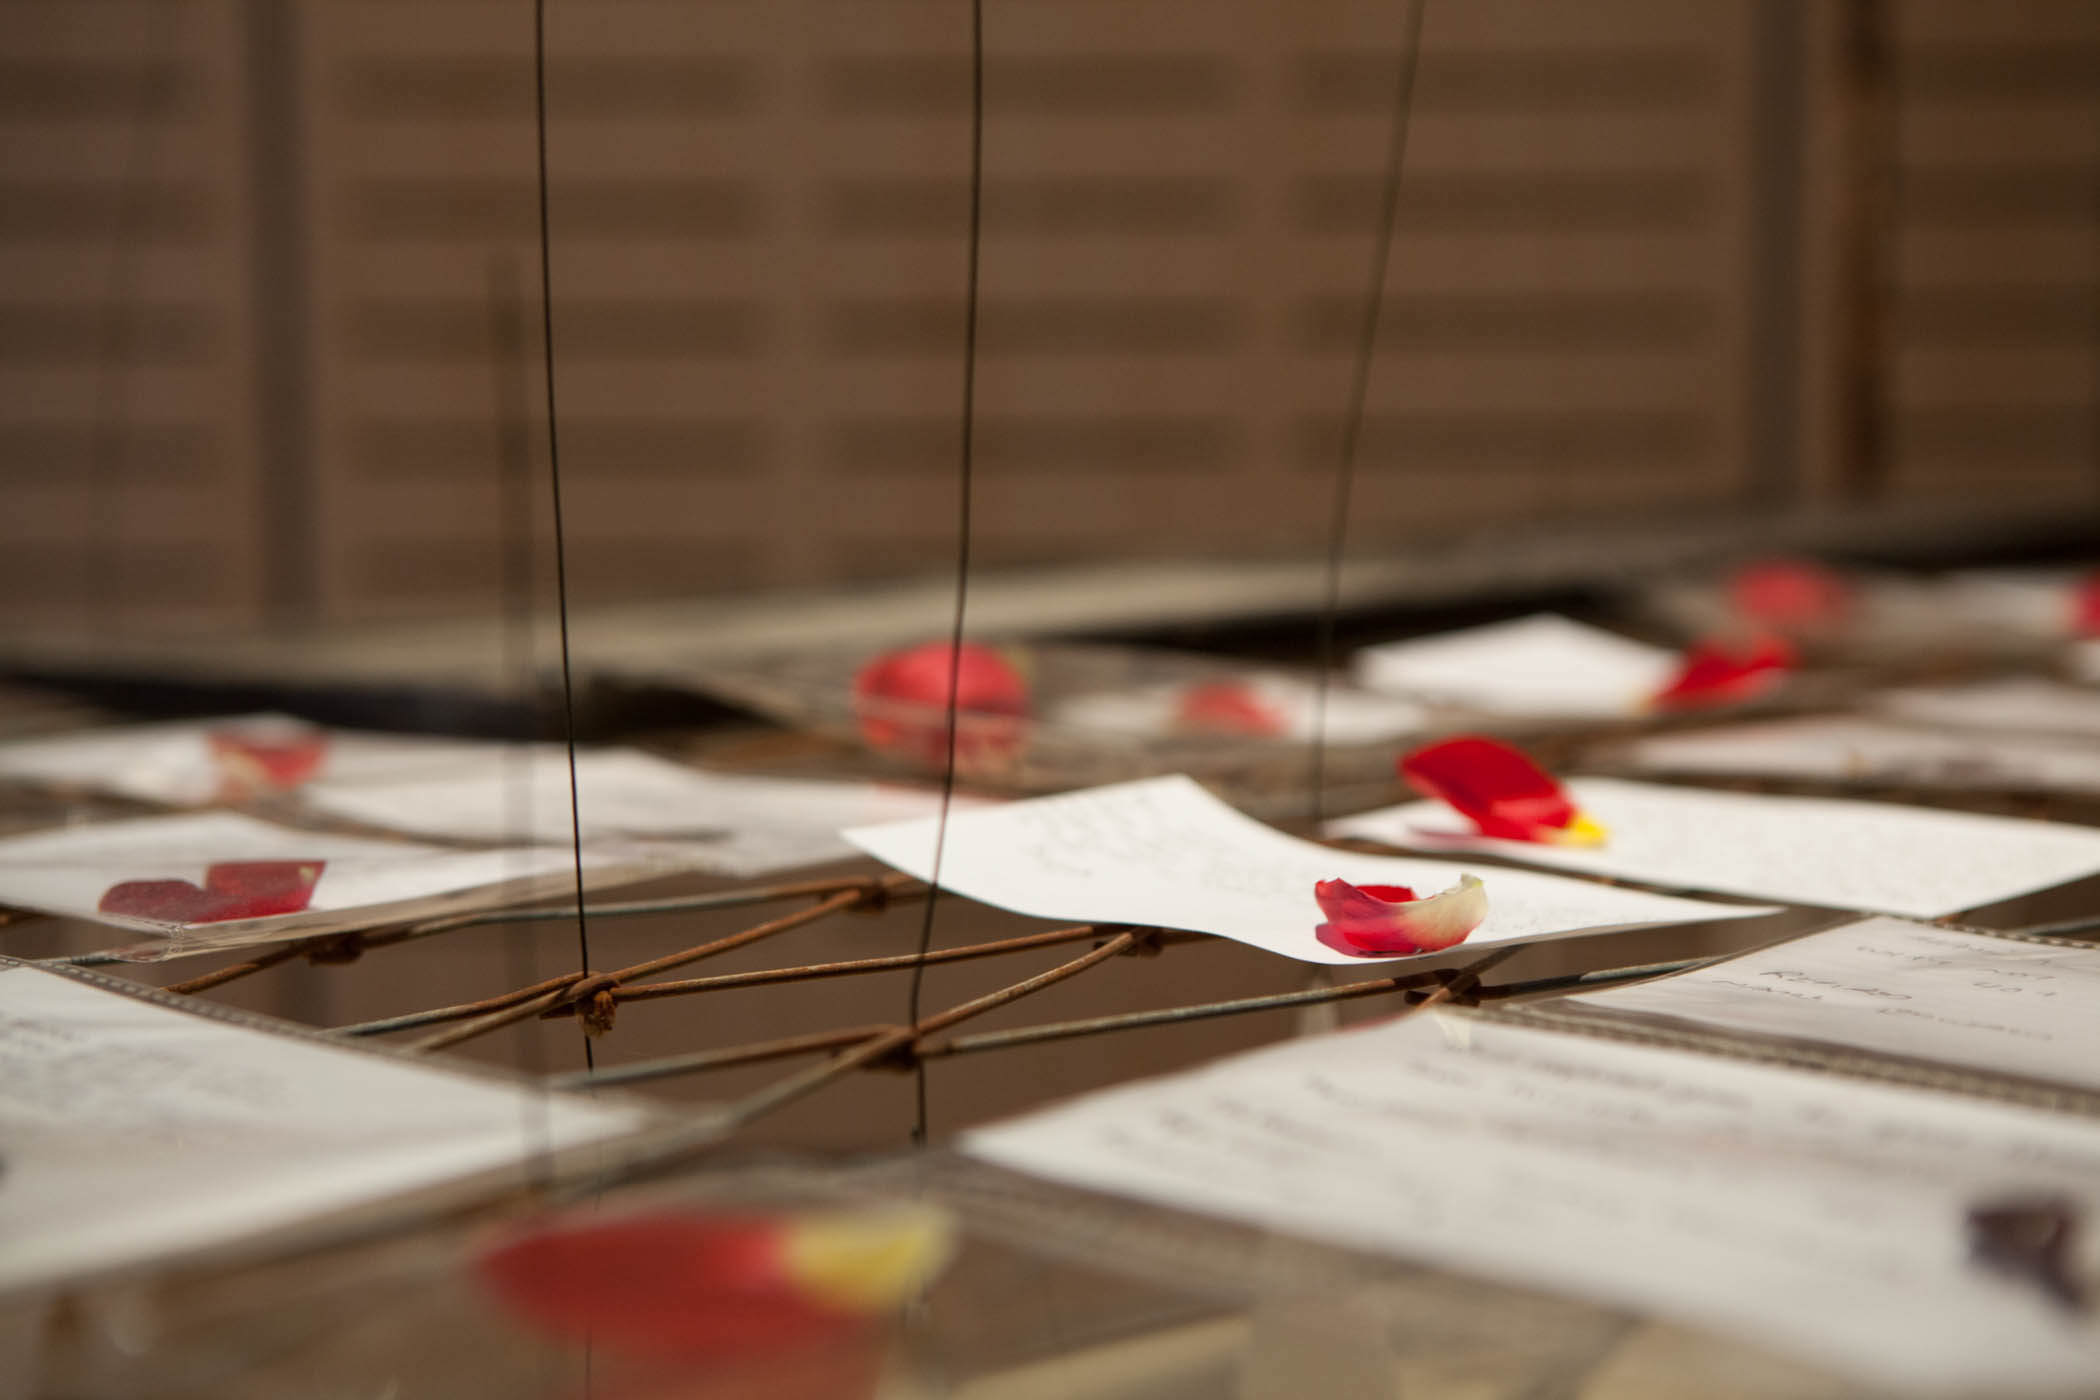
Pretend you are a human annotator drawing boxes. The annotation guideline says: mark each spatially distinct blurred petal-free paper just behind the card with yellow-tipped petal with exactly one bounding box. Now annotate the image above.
[1623,716,2100,793]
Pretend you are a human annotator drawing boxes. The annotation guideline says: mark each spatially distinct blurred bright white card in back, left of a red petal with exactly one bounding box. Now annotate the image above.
[1355,613,1678,718]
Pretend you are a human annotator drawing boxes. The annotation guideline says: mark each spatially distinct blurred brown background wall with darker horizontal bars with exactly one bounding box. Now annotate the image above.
[0,0,2100,625]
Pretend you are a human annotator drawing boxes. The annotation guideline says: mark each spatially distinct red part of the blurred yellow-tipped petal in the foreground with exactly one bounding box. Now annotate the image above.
[477,1213,865,1358]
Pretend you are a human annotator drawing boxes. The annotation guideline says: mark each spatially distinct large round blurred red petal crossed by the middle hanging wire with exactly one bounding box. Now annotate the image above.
[853,642,1029,768]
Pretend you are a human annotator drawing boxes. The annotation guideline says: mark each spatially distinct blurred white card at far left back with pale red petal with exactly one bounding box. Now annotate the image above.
[0,714,500,806]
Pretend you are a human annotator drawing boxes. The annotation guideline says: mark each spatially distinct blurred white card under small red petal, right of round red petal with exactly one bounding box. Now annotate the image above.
[1050,674,1428,745]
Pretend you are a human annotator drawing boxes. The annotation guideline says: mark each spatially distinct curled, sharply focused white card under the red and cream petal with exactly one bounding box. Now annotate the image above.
[846,777,1768,963]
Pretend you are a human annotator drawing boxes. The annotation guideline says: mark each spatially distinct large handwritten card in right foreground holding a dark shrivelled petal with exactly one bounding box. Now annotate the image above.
[964,1016,2100,1396]
